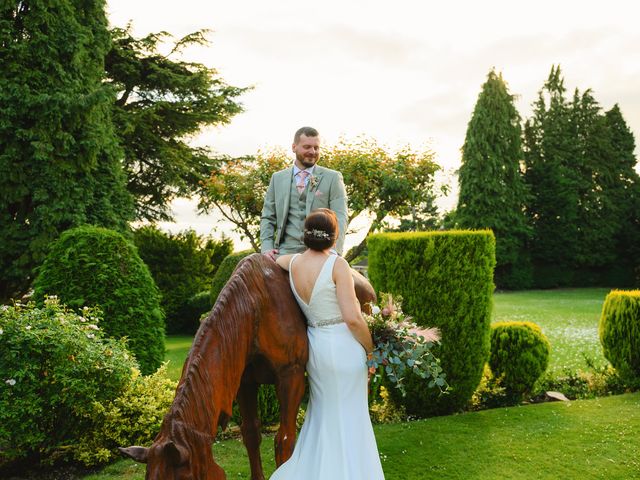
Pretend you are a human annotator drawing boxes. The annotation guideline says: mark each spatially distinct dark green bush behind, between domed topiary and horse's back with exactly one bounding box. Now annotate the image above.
[133,226,233,333]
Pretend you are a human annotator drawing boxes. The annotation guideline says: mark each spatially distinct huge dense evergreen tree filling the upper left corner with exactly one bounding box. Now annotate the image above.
[0,0,133,299]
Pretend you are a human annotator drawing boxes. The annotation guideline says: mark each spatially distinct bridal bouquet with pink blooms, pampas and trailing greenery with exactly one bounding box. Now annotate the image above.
[364,293,448,397]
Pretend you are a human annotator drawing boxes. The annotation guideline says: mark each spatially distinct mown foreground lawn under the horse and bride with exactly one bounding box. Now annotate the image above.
[84,393,640,480]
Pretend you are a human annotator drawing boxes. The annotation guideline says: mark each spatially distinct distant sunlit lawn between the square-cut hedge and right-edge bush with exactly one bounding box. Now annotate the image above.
[493,288,609,373]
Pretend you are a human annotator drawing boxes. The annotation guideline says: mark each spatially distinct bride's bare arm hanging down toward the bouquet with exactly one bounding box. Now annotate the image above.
[333,257,373,353]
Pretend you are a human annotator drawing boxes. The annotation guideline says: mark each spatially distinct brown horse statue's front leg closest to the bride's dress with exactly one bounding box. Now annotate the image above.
[275,365,304,467]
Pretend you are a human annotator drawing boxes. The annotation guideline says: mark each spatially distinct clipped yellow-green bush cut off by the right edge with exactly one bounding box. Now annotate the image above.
[599,290,640,379]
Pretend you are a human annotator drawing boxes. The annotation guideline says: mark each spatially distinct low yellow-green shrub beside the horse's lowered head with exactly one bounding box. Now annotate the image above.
[73,365,176,466]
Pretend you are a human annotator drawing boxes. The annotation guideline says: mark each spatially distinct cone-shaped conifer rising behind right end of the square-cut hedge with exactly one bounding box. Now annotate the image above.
[456,70,531,288]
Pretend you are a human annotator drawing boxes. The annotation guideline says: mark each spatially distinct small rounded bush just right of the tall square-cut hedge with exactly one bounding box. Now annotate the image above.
[489,322,551,402]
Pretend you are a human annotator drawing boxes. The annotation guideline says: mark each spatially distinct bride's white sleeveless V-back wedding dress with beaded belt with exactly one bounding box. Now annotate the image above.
[271,255,384,480]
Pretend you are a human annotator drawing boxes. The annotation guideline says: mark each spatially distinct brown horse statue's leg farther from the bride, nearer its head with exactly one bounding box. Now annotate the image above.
[236,375,264,480]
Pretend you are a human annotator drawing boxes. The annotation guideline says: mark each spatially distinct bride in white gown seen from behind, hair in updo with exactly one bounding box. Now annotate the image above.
[271,209,384,480]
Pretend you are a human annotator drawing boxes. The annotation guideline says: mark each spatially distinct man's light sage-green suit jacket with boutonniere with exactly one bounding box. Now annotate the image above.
[260,165,347,255]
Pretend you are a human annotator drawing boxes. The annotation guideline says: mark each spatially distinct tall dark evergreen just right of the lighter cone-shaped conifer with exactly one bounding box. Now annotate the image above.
[524,66,580,287]
